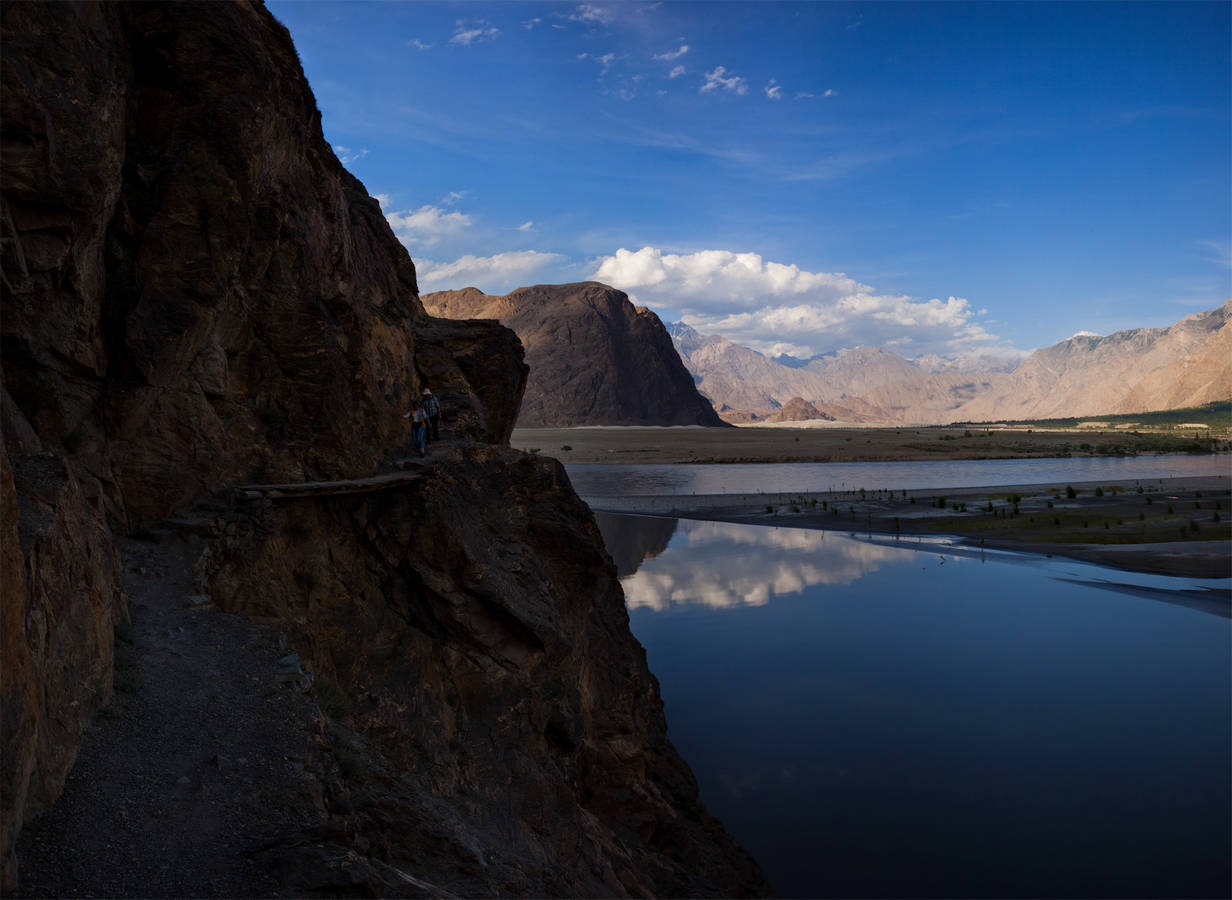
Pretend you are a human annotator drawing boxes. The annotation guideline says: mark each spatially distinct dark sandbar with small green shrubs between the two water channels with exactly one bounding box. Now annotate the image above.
[588,475,1232,577]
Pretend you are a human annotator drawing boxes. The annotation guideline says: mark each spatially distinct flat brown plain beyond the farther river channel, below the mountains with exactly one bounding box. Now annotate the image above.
[510,425,1210,465]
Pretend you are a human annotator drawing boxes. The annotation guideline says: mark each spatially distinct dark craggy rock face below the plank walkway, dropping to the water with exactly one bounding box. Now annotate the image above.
[201,447,766,896]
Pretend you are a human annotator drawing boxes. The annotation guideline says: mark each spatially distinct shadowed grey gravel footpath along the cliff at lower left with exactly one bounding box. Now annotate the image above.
[17,537,324,898]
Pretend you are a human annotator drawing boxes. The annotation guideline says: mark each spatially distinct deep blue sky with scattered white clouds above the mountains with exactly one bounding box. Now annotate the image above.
[269,0,1232,357]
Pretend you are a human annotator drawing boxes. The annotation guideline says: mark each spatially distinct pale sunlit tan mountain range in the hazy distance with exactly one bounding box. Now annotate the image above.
[670,300,1232,424]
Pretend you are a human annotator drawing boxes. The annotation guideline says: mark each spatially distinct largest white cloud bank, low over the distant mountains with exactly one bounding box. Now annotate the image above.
[591,246,997,356]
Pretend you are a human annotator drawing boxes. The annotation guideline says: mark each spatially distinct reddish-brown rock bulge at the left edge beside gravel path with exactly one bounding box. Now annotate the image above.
[0,428,128,889]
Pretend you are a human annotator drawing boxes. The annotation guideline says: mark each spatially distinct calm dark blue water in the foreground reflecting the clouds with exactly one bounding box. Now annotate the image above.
[596,514,1232,896]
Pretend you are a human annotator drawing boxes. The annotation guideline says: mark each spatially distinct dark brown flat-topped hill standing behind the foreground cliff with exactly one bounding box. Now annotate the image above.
[423,282,723,427]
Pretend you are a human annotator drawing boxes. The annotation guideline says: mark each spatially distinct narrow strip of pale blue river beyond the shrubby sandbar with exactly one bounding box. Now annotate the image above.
[565,454,1232,497]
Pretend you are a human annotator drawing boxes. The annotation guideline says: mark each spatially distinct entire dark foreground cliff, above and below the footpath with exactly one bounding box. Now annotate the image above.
[0,2,765,895]
